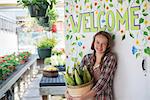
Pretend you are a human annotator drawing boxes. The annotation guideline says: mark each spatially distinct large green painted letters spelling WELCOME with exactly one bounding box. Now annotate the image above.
[69,6,140,33]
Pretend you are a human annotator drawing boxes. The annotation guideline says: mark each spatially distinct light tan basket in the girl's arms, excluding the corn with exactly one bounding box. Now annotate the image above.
[67,79,93,97]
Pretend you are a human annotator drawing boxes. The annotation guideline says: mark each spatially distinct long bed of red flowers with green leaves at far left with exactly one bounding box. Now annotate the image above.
[0,52,31,80]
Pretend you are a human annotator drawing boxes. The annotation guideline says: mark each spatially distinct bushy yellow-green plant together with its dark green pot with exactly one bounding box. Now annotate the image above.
[36,37,57,59]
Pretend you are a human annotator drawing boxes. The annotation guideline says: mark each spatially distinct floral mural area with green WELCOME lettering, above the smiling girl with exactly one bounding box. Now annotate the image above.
[65,0,150,65]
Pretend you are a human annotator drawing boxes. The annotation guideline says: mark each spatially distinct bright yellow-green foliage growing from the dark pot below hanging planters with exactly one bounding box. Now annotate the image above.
[36,37,57,48]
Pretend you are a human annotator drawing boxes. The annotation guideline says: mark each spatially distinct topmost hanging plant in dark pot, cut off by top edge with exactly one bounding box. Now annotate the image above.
[17,0,56,17]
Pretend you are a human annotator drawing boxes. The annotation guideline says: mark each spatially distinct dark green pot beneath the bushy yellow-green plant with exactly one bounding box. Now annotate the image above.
[38,48,51,59]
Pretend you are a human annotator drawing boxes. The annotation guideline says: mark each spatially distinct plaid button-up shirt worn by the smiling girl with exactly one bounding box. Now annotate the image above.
[80,53,117,100]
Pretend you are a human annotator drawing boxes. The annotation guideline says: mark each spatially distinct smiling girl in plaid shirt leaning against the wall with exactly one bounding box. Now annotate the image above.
[66,31,117,100]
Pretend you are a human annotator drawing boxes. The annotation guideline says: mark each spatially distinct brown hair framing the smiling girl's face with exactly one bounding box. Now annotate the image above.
[91,31,112,53]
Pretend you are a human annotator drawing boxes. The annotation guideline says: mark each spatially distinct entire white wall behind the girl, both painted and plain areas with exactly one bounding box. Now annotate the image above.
[65,0,150,100]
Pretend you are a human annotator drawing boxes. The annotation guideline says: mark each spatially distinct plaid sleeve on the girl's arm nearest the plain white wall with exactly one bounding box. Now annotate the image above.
[92,55,117,94]
